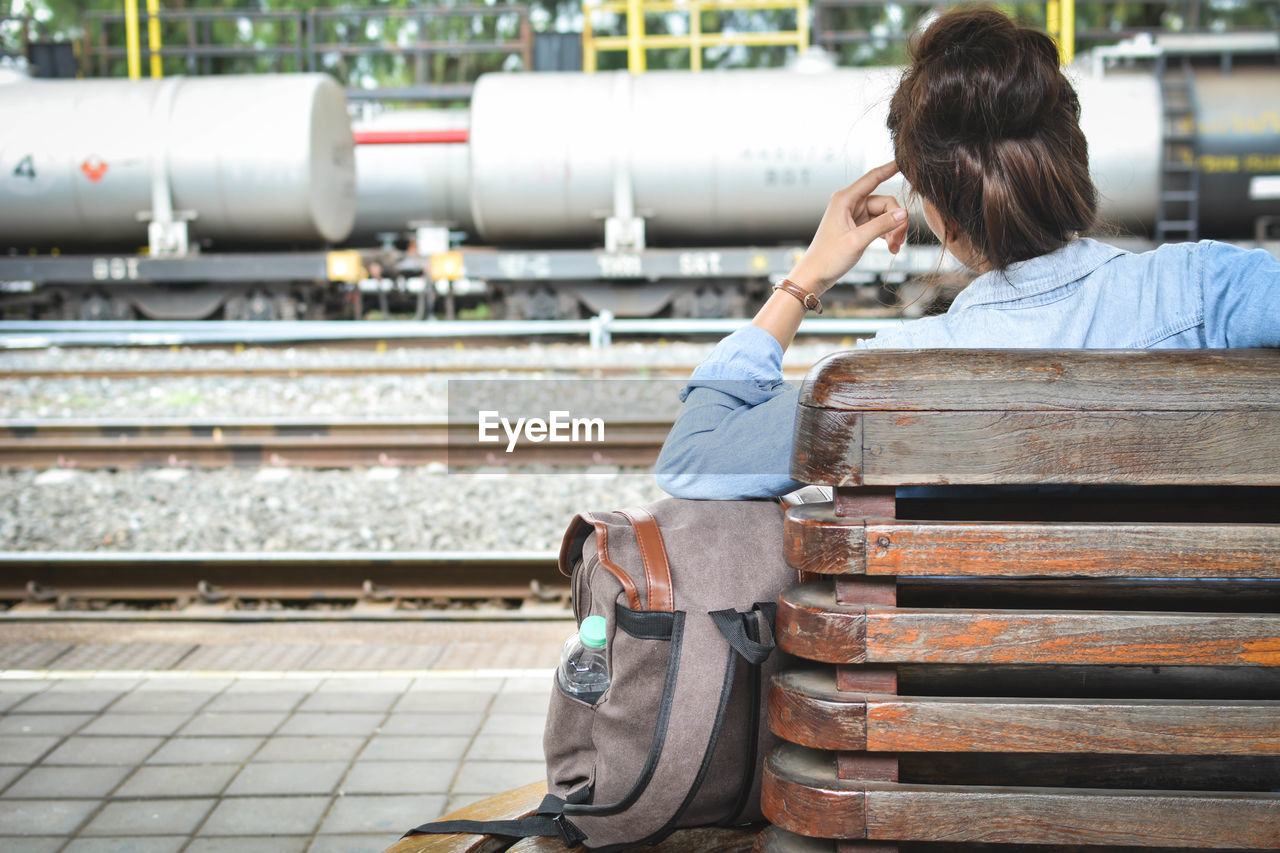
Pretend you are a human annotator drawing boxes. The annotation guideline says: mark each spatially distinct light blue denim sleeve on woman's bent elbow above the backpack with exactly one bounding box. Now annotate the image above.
[655,325,803,501]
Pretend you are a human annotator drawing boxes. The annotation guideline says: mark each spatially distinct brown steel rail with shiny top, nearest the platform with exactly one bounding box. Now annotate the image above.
[0,551,568,605]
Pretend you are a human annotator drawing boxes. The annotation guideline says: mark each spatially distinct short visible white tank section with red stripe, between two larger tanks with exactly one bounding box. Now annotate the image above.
[351,110,475,239]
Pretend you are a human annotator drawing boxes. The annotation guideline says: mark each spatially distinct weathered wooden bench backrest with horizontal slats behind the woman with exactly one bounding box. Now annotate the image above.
[758,350,1280,853]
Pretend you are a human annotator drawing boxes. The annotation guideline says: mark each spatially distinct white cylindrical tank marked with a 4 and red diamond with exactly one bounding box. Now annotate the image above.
[0,74,356,247]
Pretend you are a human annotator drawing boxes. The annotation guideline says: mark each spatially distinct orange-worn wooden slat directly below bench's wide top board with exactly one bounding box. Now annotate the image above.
[783,503,1280,578]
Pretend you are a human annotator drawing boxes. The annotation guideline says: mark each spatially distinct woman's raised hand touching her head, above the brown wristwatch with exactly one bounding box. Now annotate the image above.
[787,163,906,296]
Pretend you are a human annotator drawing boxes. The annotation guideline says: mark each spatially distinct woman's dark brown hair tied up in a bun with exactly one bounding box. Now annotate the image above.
[888,8,1097,269]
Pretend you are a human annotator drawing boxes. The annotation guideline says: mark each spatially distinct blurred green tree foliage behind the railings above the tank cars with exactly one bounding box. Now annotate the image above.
[10,0,1280,81]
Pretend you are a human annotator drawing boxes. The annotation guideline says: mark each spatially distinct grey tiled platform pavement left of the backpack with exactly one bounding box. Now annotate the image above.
[0,622,572,853]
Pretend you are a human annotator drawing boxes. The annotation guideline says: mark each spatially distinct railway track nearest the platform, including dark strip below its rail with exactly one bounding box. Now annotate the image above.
[0,551,568,619]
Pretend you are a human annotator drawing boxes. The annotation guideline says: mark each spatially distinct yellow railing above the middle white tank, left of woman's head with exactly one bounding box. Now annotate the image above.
[582,0,809,73]
